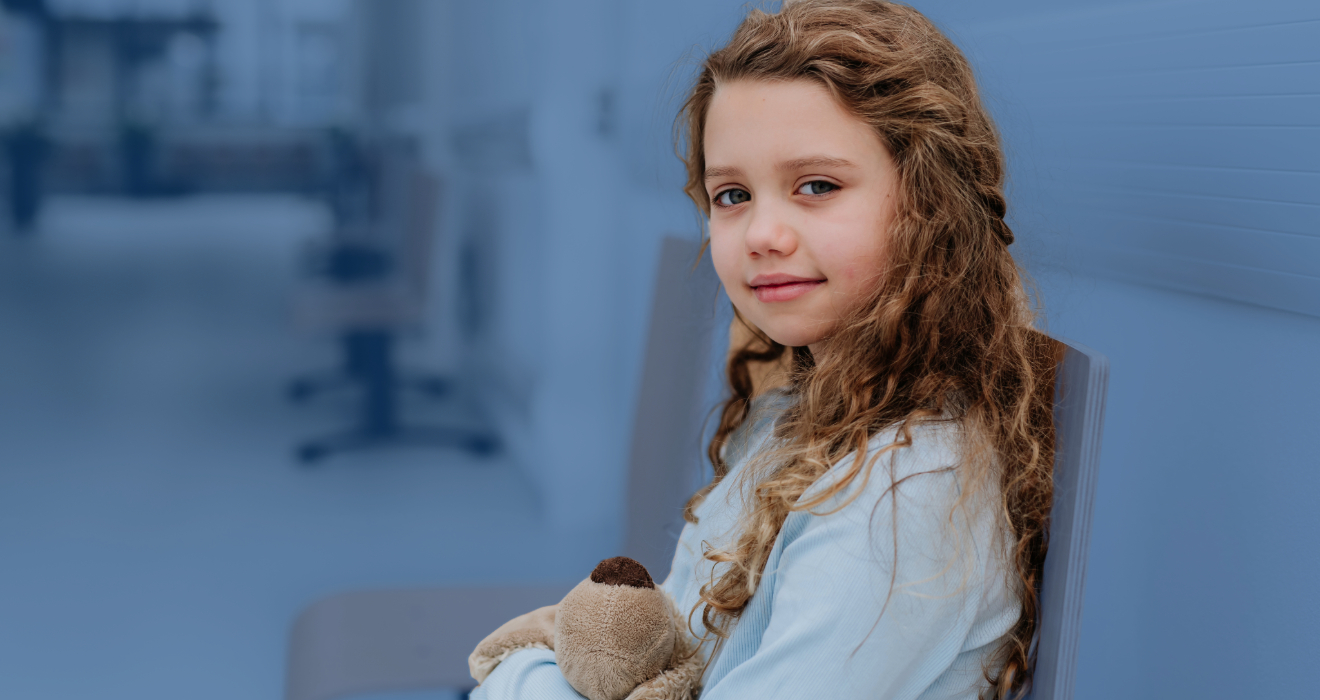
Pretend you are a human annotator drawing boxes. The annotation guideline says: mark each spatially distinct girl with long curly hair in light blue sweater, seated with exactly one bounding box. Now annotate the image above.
[473,0,1053,700]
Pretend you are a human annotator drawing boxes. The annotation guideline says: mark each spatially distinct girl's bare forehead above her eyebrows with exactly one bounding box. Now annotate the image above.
[702,79,887,168]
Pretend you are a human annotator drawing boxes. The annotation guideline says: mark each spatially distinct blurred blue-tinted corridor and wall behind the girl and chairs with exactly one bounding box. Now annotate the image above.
[0,0,1320,700]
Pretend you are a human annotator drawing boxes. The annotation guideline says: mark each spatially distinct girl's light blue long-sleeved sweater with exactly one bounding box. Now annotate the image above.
[471,392,1019,700]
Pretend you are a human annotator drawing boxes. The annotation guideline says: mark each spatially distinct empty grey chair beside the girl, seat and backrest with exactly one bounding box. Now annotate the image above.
[285,238,718,700]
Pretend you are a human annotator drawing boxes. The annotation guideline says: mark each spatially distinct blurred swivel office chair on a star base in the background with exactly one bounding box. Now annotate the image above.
[289,138,499,462]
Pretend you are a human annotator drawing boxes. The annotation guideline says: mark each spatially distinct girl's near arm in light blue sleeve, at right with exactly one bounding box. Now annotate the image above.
[701,435,1016,700]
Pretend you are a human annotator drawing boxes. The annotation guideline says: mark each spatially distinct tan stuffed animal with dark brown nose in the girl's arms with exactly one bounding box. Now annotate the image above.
[467,556,705,700]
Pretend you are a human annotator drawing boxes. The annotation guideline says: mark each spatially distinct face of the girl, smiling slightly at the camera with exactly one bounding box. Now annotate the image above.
[704,79,898,358]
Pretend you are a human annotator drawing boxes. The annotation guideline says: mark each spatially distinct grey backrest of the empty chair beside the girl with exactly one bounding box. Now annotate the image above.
[623,238,719,581]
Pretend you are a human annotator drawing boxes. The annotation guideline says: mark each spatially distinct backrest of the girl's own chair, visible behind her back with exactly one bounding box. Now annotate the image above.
[1030,339,1109,700]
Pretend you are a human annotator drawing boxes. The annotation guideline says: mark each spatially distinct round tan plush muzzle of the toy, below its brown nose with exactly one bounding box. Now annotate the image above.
[554,576,676,700]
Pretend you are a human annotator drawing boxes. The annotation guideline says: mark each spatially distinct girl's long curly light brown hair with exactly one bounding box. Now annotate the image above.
[676,0,1055,699]
